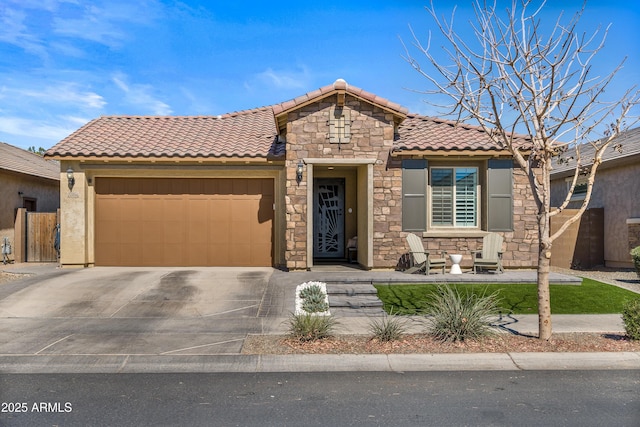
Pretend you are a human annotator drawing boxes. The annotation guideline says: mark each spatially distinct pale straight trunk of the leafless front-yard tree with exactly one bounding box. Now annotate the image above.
[538,214,552,340]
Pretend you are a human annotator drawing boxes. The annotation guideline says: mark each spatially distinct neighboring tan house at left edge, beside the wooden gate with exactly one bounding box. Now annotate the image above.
[0,142,60,260]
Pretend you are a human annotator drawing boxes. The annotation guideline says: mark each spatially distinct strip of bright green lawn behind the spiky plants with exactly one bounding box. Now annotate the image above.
[375,279,640,314]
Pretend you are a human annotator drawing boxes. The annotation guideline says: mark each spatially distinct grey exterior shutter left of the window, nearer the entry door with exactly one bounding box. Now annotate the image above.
[402,160,427,231]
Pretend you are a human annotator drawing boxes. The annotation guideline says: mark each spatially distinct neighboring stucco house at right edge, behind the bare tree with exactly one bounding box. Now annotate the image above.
[551,128,640,268]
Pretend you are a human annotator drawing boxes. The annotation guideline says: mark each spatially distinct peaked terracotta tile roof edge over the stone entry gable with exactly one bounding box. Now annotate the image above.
[273,79,409,116]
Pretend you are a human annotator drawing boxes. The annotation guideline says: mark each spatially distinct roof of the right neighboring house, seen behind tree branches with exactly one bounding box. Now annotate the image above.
[551,127,640,176]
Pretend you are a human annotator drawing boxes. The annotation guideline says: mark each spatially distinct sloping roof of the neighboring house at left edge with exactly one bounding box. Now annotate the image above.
[0,142,60,181]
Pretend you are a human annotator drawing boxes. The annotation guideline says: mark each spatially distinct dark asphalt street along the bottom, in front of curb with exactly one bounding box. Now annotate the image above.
[0,370,640,427]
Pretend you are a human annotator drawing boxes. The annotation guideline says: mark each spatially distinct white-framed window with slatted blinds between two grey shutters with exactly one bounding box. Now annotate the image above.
[431,167,478,227]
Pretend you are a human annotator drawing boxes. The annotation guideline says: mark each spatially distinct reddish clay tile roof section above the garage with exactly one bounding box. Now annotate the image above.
[47,107,284,158]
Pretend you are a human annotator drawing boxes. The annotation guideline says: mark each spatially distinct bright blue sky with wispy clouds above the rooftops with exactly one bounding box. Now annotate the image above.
[0,0,640,148]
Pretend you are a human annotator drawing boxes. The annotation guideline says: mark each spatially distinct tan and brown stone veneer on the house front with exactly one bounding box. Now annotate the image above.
[285,95,537,270]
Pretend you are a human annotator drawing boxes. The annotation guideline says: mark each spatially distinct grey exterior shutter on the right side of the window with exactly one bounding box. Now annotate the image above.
[487,159,513,231]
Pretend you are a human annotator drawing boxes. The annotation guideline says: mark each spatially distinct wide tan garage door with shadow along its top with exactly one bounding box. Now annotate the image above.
[95,178,274,266]
